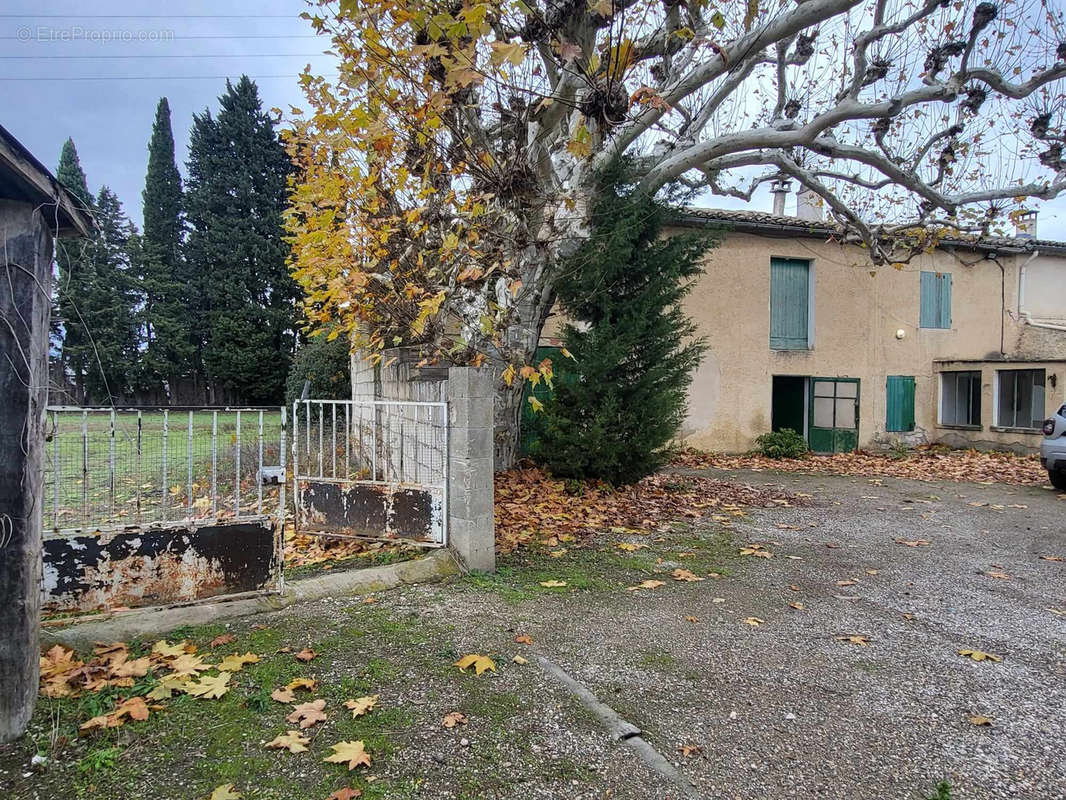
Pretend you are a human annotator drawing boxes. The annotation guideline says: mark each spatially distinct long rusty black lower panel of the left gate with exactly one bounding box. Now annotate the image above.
[42,519,280,612]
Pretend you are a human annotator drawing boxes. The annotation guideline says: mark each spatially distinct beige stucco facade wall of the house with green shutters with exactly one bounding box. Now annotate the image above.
[683,234,1063,451]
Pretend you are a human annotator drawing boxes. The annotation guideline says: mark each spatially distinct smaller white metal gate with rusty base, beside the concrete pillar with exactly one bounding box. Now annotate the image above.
[292,400,448,546]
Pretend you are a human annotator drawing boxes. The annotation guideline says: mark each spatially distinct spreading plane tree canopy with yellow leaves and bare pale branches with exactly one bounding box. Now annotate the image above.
[288,0,1066,462]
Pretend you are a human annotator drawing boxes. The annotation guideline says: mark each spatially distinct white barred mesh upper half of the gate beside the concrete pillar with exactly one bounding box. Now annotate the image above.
[293,400,448,490]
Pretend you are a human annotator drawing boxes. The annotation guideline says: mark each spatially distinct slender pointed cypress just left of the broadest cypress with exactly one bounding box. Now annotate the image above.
[134,97,194,394]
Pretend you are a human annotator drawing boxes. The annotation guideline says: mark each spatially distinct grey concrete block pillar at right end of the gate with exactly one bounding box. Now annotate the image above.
[448,367,496,572]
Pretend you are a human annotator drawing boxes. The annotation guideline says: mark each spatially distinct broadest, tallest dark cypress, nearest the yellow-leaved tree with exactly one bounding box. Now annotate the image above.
[185,76,297,403]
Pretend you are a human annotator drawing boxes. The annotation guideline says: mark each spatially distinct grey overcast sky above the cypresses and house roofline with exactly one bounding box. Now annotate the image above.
[0,0,1066,240]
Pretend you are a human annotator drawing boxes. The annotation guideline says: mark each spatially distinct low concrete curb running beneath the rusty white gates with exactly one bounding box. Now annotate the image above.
[41,548,461,649]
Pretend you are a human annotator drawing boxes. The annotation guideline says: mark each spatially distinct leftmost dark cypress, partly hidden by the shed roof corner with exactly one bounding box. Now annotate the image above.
[53,139,94,403]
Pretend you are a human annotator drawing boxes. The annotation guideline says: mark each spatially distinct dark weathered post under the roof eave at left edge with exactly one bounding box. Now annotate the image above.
[0,199,52,742]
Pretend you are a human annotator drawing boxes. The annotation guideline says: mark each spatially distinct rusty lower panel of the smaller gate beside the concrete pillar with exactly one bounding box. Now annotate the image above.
[296,480,443,542]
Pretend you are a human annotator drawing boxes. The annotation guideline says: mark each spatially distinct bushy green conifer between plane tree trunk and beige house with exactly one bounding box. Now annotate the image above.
[533,172,714,485]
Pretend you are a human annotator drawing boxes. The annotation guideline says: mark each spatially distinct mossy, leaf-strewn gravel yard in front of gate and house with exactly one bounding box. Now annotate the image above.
[6,471,1066,800]
